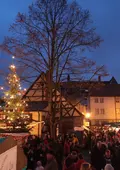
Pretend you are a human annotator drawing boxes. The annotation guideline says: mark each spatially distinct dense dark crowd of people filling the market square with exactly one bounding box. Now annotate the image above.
[23,131,120,170]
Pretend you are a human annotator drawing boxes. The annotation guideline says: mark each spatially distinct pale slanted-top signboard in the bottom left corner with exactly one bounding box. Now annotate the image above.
[0,146,17,170]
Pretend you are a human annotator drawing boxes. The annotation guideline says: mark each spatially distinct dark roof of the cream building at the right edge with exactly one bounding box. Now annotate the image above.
[90,84,120,97]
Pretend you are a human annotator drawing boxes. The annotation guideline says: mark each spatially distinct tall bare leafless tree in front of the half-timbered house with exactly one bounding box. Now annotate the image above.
[1,0,107,137]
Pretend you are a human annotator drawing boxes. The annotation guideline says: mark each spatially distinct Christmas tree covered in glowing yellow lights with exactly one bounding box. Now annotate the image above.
[4,61,31,129]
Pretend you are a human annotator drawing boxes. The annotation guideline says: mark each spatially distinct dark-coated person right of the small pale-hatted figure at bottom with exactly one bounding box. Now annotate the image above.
[45,150,58,170]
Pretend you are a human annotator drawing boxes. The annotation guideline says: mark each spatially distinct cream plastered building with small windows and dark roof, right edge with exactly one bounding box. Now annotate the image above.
[88,84,120,125]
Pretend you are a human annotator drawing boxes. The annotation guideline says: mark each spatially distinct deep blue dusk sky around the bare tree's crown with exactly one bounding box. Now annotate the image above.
[0,0,120,85]
